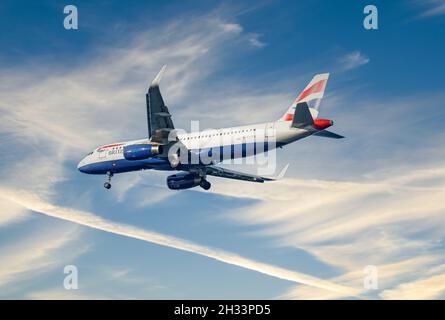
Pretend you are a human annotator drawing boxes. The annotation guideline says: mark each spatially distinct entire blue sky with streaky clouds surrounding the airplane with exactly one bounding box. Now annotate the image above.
[0,0,445,299]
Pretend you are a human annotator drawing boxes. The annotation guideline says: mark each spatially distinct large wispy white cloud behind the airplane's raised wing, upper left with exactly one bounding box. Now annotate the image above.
[0,17,256,161]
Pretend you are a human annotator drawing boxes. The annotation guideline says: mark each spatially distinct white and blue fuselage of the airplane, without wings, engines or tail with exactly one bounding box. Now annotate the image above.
[78,121,317,174]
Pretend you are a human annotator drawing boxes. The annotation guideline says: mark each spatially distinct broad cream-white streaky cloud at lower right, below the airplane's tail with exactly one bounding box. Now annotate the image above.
[209,164,445,298]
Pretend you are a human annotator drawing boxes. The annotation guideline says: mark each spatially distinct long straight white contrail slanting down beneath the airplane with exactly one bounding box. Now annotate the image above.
[0,188,358,296]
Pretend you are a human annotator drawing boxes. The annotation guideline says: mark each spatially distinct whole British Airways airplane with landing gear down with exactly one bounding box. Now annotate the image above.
[77,66,344,190]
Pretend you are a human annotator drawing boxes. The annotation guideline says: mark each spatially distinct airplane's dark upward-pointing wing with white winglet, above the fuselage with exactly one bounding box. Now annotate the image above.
[146,66,175,142]
